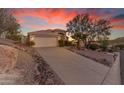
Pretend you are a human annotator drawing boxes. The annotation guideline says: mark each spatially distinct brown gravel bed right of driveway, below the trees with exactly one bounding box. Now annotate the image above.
[66,47,116,67]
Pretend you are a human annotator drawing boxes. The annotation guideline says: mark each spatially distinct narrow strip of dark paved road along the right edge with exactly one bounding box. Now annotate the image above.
[120,50,124,85]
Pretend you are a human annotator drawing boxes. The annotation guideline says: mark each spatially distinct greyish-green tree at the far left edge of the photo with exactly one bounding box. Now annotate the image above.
[0,8,20,38]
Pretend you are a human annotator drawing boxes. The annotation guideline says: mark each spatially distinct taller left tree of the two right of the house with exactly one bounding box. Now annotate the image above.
[66,14,90,49]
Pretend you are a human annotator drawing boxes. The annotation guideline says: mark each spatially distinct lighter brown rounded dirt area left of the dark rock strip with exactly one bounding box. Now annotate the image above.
[0,45,37,85]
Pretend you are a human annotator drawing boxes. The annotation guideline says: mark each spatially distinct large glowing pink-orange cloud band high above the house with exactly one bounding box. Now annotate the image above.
[13,9,77,24]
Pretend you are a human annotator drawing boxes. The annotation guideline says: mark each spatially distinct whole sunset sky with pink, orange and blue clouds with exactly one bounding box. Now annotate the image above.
[10,8,124,39]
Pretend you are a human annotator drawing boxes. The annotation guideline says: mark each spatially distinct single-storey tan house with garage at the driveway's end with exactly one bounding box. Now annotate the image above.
[28,29,65,47]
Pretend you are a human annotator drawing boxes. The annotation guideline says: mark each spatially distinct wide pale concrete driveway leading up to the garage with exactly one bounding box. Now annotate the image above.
[36,47,109,85]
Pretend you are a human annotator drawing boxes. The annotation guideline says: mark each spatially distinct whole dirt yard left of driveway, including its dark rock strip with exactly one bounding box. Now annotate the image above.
[0,45,64,85]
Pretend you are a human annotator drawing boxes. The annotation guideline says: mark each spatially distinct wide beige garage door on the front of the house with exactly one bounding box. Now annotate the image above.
[34,37,58,47]
